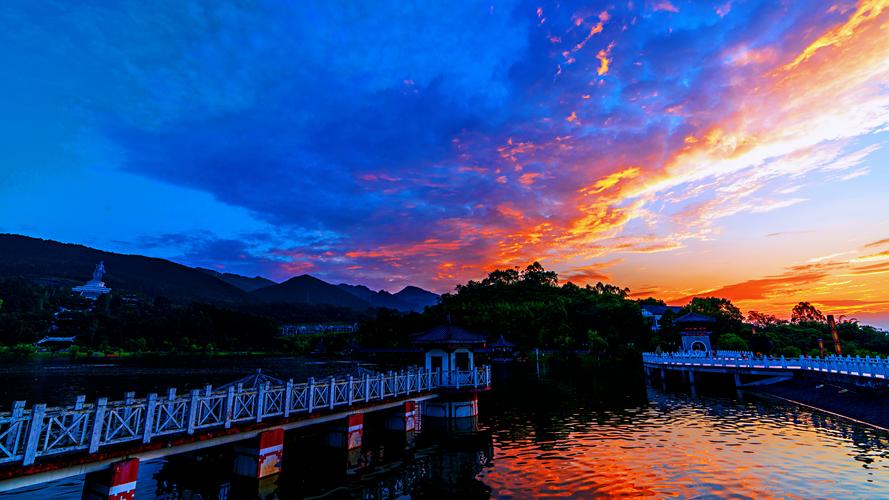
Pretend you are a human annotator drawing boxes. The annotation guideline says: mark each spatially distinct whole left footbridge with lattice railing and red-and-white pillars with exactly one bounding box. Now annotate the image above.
[0,367,490,499]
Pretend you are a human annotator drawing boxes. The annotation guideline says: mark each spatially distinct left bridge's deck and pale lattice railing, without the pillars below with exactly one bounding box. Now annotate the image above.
[0,367,490,491]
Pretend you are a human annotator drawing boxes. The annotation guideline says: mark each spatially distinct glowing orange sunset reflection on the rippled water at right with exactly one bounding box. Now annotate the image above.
[480,392,889,498]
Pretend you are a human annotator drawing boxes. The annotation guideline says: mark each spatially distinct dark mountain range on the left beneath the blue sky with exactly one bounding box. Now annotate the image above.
[0,234,439,311]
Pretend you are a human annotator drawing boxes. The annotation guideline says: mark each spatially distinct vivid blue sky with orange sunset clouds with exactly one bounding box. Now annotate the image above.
[0,0,889,327]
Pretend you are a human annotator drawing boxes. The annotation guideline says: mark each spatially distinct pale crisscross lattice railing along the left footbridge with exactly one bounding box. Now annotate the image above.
[0,367,491,466]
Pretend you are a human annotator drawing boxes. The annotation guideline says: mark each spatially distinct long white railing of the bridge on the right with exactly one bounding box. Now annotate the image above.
[642,351,889,379]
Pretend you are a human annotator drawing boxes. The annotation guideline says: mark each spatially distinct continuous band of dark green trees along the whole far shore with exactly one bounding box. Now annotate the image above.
[0,262,889,359]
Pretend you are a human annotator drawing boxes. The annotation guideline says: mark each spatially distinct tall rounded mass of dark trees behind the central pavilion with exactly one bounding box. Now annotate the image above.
[361,262,651,357]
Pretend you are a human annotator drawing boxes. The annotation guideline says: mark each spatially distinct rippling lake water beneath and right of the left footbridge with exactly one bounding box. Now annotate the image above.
[0,360,889,499]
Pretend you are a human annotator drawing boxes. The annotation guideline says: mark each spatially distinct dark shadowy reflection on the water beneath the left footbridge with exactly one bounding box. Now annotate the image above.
[144,418,493,500]
